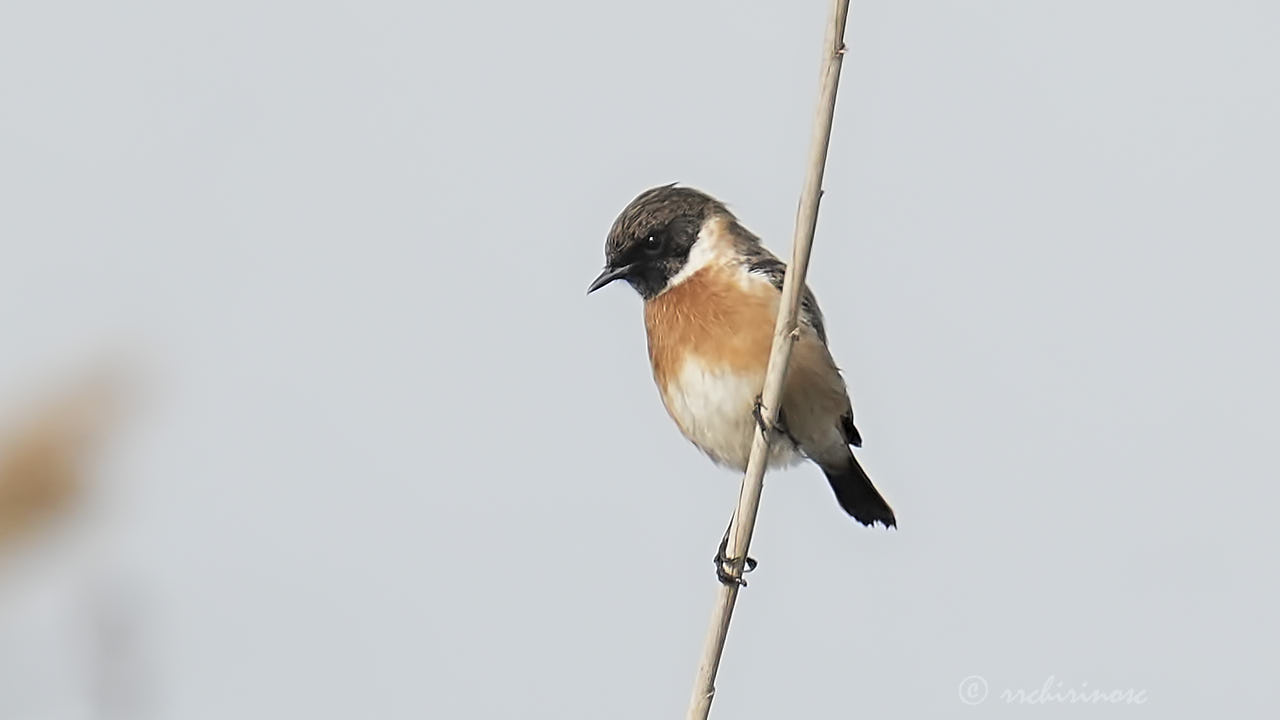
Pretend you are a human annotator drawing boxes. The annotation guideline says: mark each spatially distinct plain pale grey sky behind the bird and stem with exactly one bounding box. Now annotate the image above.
[0,0,1280,720]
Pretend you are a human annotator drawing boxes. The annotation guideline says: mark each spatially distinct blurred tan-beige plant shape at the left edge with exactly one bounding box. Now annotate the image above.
[0,372,122,551]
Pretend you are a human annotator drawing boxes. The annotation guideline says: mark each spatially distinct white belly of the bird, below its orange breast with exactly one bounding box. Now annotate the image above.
[662,356,800,471]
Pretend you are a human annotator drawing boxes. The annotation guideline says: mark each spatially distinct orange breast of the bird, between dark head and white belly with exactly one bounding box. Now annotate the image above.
[644,266,780,392]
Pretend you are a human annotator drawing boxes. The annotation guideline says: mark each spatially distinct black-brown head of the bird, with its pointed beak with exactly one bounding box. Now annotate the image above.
[586,184,732,299]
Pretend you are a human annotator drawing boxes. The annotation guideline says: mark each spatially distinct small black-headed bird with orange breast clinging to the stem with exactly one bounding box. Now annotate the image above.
[586,183,897,566]
